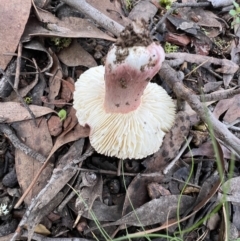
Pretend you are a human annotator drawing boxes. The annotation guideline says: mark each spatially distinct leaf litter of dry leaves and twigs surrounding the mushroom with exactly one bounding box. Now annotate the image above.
[0,0,240,240]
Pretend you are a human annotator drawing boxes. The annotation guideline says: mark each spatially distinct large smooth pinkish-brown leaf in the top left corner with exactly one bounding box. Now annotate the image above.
[0,0,31,69]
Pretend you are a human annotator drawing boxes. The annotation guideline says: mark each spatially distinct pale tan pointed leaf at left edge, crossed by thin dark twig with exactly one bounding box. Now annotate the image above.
[0,102,54,123]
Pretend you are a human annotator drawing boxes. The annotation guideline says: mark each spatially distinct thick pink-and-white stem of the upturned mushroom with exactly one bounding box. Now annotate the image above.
[104,43,165,113]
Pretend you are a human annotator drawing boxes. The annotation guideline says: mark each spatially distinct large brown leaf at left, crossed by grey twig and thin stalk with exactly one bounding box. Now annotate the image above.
[13,118,53,205]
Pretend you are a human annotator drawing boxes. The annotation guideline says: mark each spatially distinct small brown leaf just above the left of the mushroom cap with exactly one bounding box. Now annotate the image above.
[58,40,97,68]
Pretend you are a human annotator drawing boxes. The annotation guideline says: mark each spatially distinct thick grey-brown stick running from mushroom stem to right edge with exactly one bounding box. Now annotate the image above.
[159,62,240,155]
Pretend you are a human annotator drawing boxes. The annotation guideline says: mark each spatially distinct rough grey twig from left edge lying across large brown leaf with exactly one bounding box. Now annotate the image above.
[0,124,46,163]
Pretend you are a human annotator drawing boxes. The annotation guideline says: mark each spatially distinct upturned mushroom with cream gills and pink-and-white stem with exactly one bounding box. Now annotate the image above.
[73,21,175,159]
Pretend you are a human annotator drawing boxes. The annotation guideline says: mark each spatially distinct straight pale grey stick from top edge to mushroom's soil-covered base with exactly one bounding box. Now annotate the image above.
[62,0,124,36]
